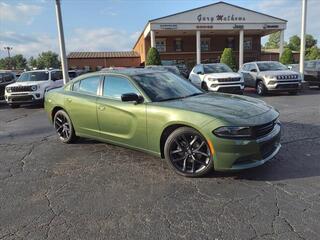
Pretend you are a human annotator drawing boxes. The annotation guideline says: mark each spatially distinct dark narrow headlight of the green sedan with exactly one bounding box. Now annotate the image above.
[213,127,252,138]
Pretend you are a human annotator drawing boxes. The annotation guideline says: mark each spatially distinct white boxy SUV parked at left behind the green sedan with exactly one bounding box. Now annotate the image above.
[5,69,63,108]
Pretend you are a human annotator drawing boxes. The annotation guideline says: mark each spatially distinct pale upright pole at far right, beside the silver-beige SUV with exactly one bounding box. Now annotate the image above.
[299,0,307,81]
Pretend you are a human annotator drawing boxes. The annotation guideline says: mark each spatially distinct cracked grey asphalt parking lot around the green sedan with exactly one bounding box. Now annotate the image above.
[0,89,320,239]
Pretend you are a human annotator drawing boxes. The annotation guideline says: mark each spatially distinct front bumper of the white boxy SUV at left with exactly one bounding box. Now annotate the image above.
[5,92,43,104]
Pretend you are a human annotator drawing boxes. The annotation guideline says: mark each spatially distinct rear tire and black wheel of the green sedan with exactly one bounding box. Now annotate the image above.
[53,110,76,143]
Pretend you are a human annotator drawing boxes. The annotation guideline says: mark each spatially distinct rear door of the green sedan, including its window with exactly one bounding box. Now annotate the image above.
[64,75,100,137]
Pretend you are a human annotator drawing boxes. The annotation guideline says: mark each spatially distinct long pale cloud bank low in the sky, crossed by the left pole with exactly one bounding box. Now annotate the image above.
[0,28,140,57]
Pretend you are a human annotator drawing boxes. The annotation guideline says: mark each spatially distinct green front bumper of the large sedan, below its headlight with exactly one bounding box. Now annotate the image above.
[211,124,281,171]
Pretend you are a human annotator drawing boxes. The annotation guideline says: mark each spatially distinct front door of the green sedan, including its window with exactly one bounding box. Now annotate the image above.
[97,74,147,148]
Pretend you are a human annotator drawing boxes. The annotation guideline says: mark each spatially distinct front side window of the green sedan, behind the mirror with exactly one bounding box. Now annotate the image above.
[103,76,140,100]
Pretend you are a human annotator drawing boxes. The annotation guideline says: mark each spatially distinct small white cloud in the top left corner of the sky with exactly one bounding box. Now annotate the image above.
[0,2,43,25]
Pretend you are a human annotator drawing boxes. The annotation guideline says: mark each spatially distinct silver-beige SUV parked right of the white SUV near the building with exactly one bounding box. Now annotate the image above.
[239,61,302,95]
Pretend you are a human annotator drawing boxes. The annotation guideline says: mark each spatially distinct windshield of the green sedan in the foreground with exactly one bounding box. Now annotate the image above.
[132,72,203,102]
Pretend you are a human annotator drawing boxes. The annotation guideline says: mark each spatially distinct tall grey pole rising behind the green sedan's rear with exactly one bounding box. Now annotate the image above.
[56,0,69,84]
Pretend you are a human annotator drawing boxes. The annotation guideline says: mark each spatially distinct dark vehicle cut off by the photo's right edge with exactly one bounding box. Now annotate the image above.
[304,60,320,88]
